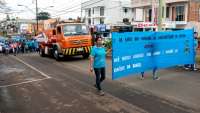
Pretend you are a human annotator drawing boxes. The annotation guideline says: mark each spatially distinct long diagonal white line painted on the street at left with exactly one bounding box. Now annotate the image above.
[12,56,51,78]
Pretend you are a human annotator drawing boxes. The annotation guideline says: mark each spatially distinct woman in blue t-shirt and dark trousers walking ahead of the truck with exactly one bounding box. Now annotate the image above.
[90,37,111,96]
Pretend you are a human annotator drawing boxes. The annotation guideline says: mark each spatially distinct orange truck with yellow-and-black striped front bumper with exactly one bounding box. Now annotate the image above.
[39,22,92,60]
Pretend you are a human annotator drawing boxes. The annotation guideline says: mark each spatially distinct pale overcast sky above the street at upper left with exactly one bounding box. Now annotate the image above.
[0,0,88,19]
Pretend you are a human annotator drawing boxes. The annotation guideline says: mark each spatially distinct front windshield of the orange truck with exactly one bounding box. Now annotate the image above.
[63,25,89,36]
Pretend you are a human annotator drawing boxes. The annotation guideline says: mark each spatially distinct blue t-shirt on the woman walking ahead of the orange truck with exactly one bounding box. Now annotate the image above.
[90,46,106,68]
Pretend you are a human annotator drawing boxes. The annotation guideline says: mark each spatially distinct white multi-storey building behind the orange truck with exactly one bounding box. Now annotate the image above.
[81,0,133,25]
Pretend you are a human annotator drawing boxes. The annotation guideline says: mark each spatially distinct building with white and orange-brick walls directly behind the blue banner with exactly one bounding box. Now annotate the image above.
[132,0,200,31]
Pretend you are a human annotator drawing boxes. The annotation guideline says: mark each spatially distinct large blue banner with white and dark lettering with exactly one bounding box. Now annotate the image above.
[112,30,194,79]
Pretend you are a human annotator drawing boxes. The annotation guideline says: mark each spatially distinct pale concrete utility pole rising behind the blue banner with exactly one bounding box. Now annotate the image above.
[158,0,166,31]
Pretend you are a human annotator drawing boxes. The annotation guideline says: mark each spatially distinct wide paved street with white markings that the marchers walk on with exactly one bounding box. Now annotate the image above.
[0,53,200,113]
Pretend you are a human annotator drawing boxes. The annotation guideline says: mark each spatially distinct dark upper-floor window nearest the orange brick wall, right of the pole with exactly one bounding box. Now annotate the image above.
[176,6,185,21]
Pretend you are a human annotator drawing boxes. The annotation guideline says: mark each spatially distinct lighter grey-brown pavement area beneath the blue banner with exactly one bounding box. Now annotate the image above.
[106,59,200,111]
